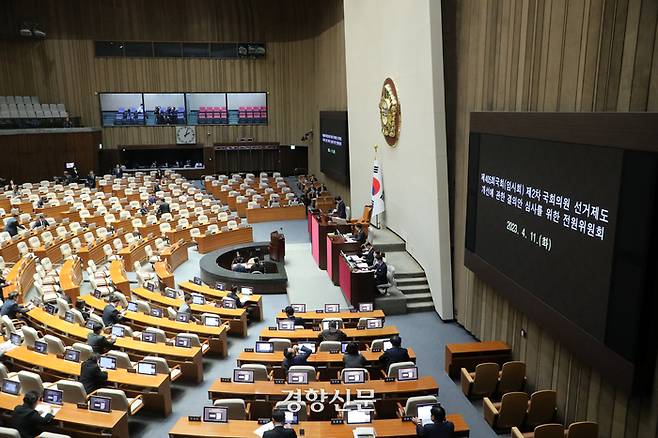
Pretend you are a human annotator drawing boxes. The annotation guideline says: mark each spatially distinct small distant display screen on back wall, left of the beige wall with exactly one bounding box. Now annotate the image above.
[320,111,350,183]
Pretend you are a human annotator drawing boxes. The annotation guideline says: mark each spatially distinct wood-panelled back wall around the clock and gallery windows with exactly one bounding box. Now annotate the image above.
[0,0,349,194]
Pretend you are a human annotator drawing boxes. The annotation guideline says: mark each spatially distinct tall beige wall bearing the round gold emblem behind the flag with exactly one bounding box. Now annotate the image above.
[345,0,452,319]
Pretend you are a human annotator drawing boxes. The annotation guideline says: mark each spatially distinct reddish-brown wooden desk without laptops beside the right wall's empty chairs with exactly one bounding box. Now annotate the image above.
[445,341,512,377]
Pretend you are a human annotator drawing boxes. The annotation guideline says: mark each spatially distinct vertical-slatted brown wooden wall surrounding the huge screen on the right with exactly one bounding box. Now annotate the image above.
[444,0,658,438]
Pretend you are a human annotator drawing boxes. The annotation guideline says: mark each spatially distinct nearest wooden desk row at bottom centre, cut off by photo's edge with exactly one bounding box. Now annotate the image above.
[169,414,470,438]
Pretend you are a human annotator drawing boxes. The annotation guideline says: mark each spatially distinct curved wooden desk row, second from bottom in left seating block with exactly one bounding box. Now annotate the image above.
[4,345,171,416]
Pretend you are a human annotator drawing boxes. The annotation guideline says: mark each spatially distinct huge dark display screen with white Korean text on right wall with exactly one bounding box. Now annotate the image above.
[465,129,658,376]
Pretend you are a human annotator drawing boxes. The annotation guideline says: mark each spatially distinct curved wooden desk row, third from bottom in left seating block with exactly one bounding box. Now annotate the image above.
[27,308,203,383]
